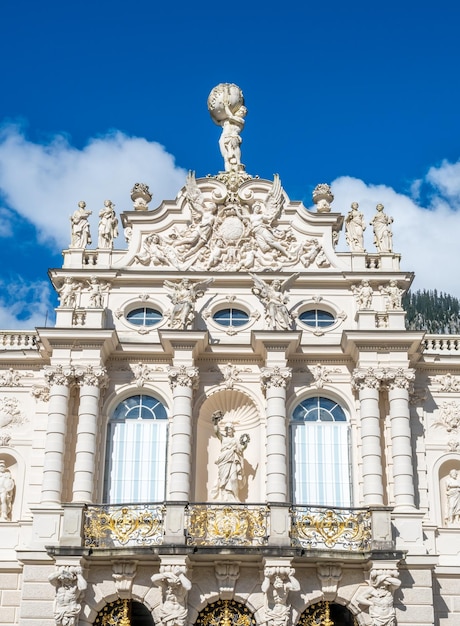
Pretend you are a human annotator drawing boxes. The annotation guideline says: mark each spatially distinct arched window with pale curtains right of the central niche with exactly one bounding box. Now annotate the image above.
[291,396,351,507]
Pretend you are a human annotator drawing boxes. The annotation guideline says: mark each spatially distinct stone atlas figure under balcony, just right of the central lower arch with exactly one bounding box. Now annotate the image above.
[262,567,300,626]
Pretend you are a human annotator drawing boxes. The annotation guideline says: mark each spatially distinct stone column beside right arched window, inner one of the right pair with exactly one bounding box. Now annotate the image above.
[353,368,383,506]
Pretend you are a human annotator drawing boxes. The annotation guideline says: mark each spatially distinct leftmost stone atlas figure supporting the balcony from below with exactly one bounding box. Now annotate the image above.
[48,566,87,626]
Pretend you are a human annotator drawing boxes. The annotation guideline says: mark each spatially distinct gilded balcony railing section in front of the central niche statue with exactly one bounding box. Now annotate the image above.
[186,503,269,546]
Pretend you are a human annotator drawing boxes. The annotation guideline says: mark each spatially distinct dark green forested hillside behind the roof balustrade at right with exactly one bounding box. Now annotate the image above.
[402,289,460,335]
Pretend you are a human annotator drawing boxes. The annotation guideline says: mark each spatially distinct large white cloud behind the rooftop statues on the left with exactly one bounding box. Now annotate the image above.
[0,124,186,248]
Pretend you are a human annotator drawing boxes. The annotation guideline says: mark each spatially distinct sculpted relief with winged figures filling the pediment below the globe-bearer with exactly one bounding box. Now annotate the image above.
[134,172,329,272]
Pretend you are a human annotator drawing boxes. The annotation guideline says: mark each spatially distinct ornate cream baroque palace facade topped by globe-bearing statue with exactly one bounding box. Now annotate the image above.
[0,83,460,626]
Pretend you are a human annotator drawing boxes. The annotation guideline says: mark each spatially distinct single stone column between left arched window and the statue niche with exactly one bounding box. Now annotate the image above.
[168,365,199,502]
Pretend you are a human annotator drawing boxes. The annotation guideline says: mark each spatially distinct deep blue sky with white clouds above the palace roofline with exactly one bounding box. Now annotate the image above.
[0,0,460,328]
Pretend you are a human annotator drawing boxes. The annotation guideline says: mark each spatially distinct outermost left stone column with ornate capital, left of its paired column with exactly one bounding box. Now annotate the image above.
[42,365,73,505]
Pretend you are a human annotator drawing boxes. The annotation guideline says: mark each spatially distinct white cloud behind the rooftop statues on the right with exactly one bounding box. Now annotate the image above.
[332,172,460,297]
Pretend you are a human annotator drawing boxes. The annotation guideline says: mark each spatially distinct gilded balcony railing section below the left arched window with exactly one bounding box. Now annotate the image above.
[83,504,165,548]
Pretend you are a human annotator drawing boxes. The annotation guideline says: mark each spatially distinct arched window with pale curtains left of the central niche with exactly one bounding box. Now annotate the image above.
[104,395,168,504]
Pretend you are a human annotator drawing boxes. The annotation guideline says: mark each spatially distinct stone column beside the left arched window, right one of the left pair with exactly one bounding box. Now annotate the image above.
[72,365,107,503]
